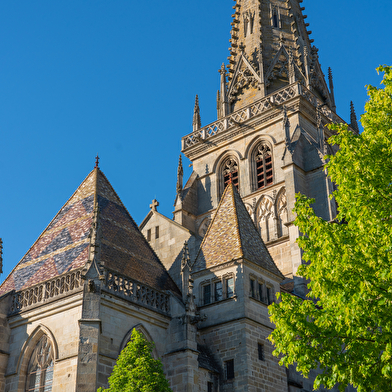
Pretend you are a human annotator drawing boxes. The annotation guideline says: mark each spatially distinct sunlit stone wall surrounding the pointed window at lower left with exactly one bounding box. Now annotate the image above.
[5,292,82,392]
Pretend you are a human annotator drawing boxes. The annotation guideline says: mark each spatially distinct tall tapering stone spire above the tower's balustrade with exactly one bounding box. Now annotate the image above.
[225,0,333,112]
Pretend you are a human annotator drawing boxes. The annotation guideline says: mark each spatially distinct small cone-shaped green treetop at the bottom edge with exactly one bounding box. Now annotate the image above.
[98,329,171,392]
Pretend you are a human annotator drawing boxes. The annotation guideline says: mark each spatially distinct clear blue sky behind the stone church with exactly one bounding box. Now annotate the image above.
[0,0,392,282]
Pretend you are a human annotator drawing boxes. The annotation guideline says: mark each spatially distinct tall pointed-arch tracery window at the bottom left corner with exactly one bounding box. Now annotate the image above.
[26,335,53,392]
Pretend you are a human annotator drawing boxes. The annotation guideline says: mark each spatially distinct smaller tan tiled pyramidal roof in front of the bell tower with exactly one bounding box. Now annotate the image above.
[192,184,284,279]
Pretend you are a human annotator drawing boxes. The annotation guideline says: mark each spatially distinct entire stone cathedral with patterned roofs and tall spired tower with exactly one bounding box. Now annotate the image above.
[0,0,358,392]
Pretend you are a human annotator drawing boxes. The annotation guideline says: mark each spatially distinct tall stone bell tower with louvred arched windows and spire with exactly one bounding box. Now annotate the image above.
[177,0,350,294]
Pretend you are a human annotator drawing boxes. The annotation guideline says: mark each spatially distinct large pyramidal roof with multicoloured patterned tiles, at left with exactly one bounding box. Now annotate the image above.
[0,168,180,295]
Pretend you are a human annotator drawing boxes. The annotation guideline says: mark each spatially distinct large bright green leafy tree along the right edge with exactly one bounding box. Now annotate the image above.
[269,66,392,391]
